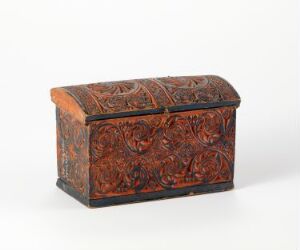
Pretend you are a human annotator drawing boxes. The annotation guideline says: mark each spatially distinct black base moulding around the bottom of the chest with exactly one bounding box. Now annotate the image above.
[56,178,233,207]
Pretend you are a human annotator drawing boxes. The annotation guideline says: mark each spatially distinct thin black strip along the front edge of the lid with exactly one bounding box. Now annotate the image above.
[85,100,240,122]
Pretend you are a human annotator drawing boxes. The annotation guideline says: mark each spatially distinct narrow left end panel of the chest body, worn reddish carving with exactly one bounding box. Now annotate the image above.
[56,109,89,197]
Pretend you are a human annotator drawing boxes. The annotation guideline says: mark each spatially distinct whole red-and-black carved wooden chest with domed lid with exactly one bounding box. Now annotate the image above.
[51,75,240,207]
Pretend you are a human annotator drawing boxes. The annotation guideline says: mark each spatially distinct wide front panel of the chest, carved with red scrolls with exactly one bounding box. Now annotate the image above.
[89,107,235,199]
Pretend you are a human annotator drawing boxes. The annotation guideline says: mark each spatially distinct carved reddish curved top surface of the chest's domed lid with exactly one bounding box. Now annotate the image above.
[64,76,239,115]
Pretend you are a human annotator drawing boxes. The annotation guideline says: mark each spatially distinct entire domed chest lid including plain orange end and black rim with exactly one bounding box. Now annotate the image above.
[51,75,240,122]
